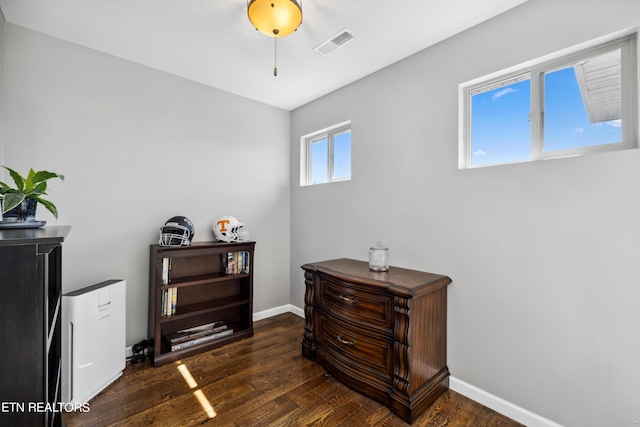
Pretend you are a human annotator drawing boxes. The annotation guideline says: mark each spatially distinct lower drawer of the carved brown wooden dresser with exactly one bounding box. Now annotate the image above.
[317,312,393,376]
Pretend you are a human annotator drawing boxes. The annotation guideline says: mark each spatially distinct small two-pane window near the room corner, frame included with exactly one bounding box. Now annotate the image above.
[300,122,351,185]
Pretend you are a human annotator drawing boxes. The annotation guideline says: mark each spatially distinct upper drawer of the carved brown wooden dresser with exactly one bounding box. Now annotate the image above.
[318,277,393,333]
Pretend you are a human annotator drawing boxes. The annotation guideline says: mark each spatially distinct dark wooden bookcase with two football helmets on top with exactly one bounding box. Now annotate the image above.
[149,242,255,366]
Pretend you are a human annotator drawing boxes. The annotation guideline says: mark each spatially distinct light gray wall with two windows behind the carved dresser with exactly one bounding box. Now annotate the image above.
[291,0,640,427]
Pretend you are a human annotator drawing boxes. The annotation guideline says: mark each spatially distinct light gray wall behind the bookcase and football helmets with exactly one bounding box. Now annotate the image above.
[5,24,290,345]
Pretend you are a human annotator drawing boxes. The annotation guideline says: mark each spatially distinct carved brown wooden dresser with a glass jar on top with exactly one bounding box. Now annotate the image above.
[302,258,451,423]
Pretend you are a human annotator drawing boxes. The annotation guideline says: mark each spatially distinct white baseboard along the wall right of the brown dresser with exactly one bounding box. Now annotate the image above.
[449,377,562,427]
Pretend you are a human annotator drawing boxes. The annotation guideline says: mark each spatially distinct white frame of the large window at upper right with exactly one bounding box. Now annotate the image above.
[458,30,638,169]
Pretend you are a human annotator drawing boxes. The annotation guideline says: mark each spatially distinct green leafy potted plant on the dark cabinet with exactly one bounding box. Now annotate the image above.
[0,166,64,221]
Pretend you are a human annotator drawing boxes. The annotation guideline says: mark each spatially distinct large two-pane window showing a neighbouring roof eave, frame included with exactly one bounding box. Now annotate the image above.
[459,34,638,168]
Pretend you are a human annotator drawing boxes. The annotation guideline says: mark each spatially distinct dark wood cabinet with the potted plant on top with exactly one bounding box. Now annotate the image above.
[0,226,71,427]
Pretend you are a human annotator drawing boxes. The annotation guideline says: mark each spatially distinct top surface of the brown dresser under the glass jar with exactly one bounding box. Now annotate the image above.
[302,258,451,293]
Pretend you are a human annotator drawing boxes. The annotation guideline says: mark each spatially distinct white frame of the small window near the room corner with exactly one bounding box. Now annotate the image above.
[300,120,353,186]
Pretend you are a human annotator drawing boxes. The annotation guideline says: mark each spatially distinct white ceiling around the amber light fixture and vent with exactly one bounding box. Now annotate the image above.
[0,0,526,110]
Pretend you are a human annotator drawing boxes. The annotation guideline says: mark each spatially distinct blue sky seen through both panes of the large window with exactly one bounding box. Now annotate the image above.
[471,56,622,166]
